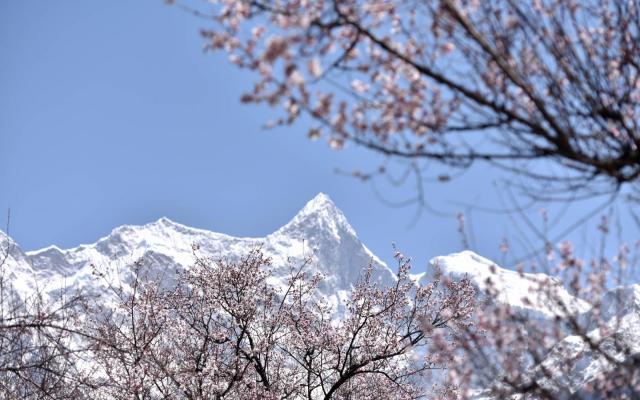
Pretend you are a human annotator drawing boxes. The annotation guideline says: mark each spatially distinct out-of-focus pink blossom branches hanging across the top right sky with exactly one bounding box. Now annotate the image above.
[174,0,640,195]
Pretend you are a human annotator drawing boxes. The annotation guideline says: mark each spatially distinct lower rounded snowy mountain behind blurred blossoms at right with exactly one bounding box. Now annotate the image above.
[420,251,640,400]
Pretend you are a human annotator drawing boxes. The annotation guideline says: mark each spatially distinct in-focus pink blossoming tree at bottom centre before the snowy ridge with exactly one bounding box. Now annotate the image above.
[85,250,474,399]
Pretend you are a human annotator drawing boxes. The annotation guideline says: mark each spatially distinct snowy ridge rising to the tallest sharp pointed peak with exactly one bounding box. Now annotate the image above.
[20,193,394,302]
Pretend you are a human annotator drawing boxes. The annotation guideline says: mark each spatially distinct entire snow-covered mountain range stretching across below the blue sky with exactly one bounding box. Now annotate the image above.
[0,194,640,392]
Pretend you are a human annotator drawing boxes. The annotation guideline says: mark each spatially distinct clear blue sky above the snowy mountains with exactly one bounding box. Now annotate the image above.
[0,0,632,267]
